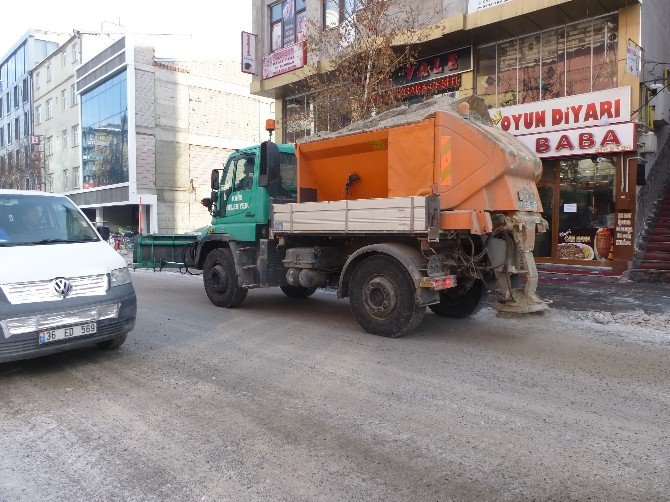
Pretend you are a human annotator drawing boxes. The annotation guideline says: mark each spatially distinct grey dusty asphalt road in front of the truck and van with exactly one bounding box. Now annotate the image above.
[0,272,670,502]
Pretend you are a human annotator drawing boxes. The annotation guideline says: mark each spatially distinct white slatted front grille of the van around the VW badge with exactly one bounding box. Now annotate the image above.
[0,274,108,305]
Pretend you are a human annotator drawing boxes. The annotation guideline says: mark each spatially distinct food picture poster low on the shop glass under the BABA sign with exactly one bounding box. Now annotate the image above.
[558,227,614,261]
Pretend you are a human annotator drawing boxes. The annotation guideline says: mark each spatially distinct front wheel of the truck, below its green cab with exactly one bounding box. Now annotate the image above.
[202,248,247,308]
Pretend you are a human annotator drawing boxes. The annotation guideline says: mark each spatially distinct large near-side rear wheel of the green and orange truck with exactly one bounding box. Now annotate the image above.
[349,256,426,338]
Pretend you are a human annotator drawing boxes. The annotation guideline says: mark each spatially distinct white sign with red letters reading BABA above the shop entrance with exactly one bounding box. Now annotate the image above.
[517,122,637,158]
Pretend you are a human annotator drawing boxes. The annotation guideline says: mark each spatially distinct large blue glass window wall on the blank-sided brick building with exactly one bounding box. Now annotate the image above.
[81,71,128,188]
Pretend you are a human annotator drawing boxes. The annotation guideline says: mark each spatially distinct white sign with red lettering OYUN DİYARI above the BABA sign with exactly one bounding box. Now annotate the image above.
[489,87,631,136]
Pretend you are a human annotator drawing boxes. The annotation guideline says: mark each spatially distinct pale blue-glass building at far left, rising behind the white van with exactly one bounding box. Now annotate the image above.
[0,30,64,189]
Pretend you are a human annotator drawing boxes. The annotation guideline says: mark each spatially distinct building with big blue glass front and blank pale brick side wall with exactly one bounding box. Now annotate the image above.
[66,37,274,233]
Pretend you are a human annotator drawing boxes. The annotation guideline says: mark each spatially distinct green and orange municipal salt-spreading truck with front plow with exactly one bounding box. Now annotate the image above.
[136,98,547,337]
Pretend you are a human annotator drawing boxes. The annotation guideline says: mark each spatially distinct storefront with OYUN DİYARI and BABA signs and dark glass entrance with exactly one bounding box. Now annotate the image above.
[491,87,637,272]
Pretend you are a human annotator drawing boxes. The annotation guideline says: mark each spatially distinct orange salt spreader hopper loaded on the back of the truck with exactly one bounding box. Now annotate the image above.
[296,98,547,313]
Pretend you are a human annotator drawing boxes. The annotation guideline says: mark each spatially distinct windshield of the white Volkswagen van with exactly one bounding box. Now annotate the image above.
[0,194,100,247]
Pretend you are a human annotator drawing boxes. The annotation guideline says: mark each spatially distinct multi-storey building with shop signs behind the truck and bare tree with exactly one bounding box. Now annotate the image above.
[251,0,670,274]
